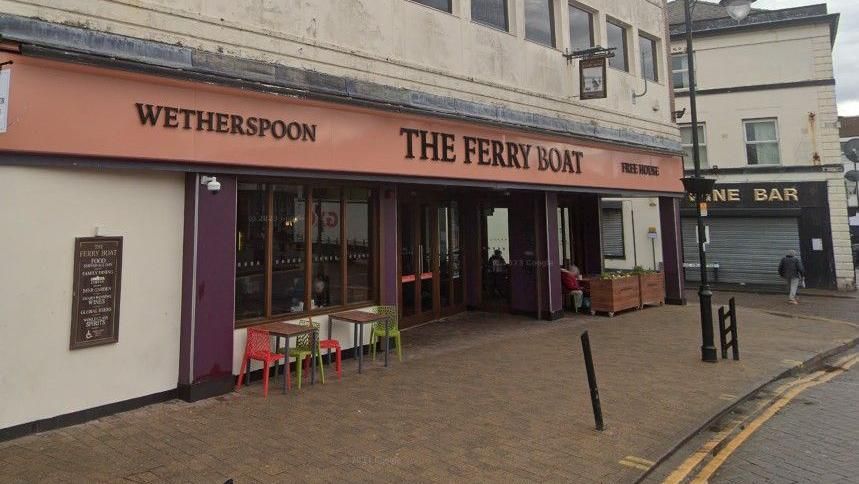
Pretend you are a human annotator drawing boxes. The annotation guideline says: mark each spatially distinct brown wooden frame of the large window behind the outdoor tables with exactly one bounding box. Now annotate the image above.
[233,179,381,329]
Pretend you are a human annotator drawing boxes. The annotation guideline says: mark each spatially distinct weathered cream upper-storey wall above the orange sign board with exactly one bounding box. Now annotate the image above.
[0,0,677,143]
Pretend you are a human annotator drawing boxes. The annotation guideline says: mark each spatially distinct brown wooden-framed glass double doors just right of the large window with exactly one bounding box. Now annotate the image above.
[398,196,465,327]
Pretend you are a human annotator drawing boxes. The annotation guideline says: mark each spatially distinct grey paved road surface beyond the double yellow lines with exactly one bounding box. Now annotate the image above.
[710,352,859,483]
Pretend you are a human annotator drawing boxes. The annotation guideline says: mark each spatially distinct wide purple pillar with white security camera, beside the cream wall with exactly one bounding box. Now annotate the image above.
[179,174,236,401]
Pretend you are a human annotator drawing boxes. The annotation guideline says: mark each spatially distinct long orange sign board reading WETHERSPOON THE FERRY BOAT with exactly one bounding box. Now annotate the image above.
[0,55,683,193]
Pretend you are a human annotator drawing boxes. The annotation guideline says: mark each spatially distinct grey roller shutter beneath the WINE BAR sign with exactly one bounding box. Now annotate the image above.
[683,217,799,285]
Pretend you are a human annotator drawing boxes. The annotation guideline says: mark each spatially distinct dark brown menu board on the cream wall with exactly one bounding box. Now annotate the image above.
[69,237,122,350]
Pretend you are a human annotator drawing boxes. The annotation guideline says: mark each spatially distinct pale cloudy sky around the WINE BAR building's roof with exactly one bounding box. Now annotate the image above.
[752,0,859,116]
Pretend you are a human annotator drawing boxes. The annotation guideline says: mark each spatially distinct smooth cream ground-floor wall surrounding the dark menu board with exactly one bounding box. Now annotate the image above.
[0,166,185,428]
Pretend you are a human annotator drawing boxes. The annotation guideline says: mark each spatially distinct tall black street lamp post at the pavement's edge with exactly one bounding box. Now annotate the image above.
[680,0,755,363]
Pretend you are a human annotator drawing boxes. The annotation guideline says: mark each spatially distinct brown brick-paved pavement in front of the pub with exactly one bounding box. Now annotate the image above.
[0,304,859,483]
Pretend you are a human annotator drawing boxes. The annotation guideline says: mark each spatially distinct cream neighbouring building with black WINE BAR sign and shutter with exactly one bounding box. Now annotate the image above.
[656,2,855,289]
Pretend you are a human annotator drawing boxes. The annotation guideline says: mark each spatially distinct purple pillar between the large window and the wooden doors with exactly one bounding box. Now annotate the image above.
[379,185,400,306]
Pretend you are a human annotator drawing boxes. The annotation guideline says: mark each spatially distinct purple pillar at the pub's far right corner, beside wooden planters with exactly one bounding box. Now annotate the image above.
[659,197,686,305]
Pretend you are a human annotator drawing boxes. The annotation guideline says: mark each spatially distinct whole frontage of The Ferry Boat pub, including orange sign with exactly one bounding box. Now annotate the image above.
[0,0,683,437]
